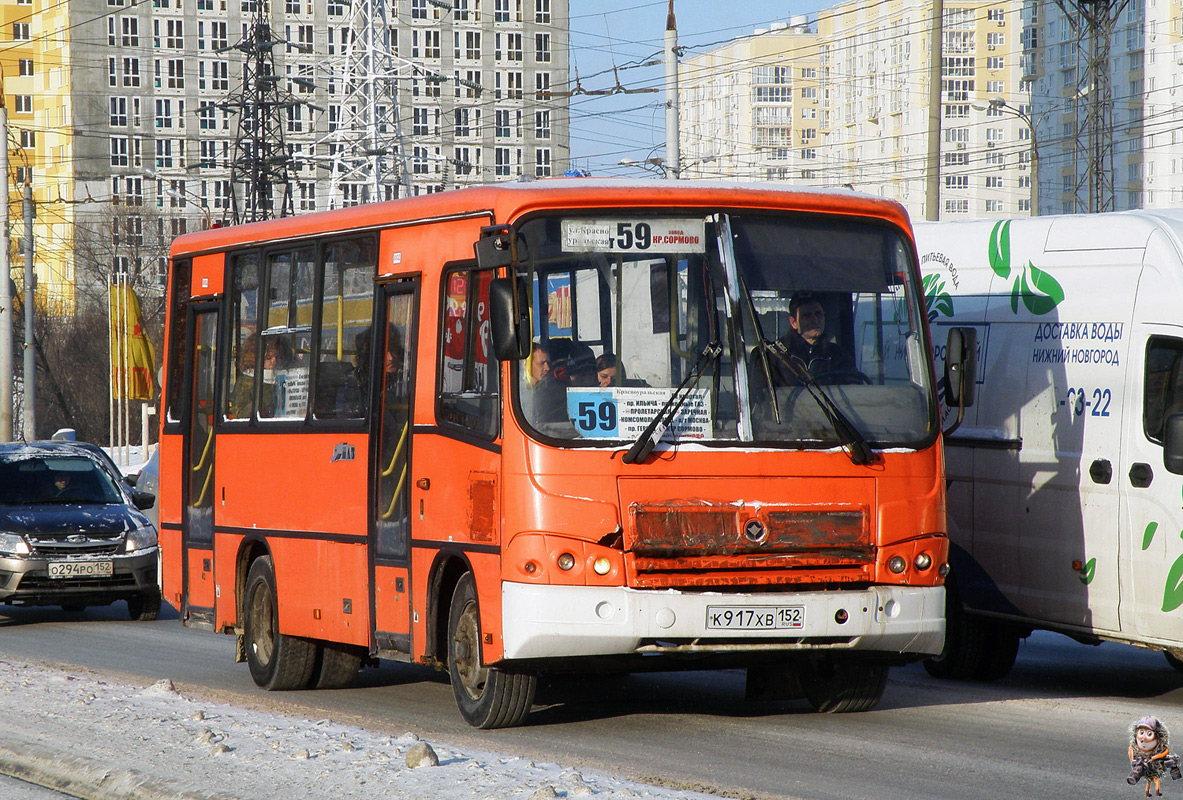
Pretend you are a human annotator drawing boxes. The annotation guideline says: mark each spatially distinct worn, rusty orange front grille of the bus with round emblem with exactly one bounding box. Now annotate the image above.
[625,503,875,587]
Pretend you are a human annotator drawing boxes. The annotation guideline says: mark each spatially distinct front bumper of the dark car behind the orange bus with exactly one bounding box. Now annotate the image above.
[0,547,160,606]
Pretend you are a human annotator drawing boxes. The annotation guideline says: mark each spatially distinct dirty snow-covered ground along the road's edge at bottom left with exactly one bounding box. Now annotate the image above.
[0,660,717,800]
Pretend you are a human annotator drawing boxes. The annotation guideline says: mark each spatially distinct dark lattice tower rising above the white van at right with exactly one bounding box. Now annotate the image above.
[1056,0,1129,212]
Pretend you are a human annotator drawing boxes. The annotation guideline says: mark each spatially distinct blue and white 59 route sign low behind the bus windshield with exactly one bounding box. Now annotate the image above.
[567,386,712,439]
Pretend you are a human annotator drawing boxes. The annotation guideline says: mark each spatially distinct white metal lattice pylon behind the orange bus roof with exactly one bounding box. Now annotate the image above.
[323,0,414,208]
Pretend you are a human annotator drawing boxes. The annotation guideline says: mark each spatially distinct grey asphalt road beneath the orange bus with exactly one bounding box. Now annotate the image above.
[0,604,1183,800]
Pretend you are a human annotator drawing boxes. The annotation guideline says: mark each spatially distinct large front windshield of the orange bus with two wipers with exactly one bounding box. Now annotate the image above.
[515,211,937,449]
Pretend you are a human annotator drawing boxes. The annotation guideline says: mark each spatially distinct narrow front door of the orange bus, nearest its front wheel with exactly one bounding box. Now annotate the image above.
[370,280,418,656]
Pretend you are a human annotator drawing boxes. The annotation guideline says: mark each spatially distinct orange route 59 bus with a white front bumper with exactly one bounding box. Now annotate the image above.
[160,180,957,728]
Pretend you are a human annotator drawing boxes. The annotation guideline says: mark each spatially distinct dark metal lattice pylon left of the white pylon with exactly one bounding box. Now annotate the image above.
[219,0,306,225]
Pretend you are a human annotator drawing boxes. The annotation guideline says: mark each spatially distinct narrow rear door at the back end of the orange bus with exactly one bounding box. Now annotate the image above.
[180,307,218,630]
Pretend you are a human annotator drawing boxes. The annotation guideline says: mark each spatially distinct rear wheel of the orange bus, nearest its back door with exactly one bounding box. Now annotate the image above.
[243,555,316,691]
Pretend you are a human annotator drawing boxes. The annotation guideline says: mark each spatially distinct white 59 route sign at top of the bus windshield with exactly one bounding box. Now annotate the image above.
[562,218,706,253]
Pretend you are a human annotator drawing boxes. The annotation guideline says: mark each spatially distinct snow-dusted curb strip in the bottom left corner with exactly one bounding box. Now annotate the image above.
[0,742,231,800]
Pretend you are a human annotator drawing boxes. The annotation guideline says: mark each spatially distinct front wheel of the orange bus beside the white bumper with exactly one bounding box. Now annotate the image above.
[447,573,538,729]
